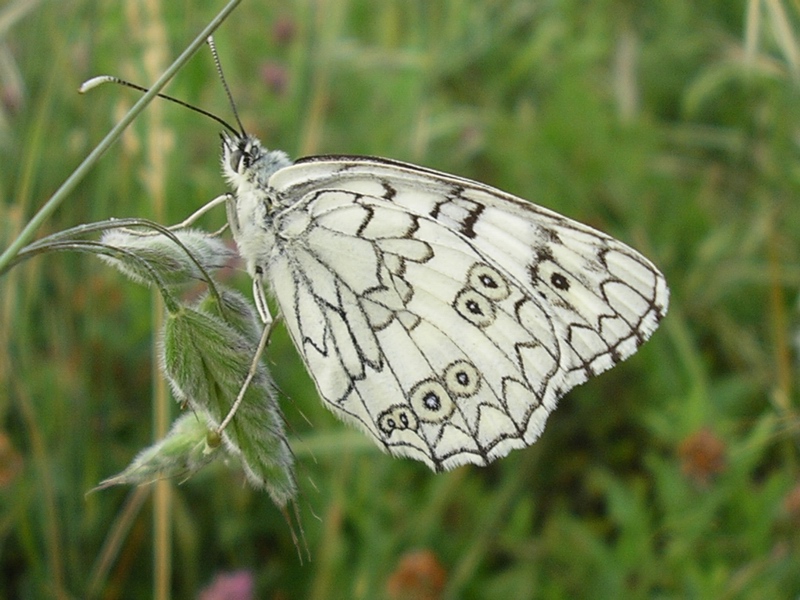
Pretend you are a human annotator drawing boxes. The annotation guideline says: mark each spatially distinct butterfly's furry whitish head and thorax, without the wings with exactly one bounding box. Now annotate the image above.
[222,133,292,276]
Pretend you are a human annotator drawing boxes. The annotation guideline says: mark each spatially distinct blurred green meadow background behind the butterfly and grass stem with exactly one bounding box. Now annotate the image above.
[0,0,800,599]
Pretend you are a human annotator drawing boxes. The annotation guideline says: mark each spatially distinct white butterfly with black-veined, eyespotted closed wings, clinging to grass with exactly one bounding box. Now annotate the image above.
[222,133,669,471]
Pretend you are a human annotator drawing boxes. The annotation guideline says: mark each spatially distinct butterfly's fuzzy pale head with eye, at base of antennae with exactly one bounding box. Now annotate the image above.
[221,133,292,192]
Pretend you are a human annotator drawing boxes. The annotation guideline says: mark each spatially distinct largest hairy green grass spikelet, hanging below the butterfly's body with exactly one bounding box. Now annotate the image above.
[162,288,296,506]
